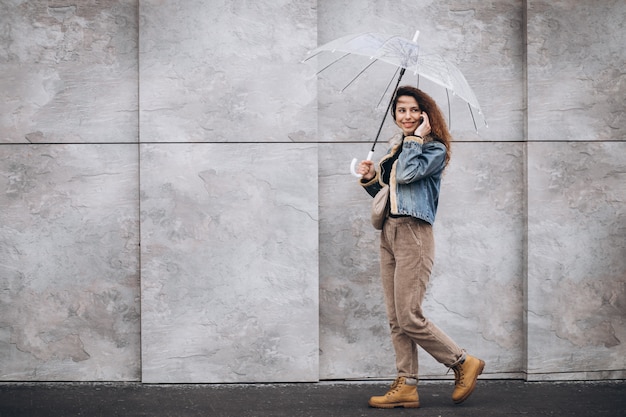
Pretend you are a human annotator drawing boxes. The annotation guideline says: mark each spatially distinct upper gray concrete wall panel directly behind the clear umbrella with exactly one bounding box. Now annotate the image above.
[317,0,525,142]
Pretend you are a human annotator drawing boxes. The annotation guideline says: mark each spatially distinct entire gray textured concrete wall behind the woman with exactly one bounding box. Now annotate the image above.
[0,0,626,383]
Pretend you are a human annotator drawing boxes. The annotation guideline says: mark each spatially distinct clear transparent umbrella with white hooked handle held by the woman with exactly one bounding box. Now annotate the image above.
[305,31,487,177]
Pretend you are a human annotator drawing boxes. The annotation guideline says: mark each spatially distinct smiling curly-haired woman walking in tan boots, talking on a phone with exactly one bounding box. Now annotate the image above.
[357,86,485,408]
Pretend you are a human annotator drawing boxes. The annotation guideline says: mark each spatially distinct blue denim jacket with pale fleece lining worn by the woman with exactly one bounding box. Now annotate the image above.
[360,136,446,224]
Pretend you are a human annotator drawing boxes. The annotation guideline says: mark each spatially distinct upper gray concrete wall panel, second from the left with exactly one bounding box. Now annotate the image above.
[139,0,317,142]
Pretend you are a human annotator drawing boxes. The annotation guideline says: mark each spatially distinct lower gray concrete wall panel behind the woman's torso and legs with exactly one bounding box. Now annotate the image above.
[320,143,525,379]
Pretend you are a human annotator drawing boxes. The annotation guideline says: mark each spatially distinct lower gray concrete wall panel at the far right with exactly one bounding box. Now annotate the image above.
[528,142,626,379]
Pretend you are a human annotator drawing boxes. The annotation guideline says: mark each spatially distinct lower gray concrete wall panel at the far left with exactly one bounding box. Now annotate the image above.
[0,144,140,381]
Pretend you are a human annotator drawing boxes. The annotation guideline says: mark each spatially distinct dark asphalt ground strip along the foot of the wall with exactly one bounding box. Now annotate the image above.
[0,379,626,417]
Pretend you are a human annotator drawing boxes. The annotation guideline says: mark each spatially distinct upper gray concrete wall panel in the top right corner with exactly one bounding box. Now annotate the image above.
[527,0,626,142]
